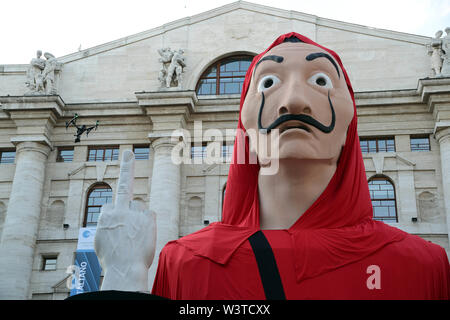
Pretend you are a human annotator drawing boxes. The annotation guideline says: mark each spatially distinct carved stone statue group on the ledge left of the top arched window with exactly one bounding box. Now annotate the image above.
[158,48,186,88]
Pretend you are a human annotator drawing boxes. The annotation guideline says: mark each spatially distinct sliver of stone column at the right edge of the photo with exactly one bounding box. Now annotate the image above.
[436,127,450,245]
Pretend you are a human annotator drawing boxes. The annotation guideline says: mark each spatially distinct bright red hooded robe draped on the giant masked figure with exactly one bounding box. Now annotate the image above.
[152,32,450,300]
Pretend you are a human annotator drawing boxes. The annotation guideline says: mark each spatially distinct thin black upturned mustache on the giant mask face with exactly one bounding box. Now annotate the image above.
[258,91,336,134]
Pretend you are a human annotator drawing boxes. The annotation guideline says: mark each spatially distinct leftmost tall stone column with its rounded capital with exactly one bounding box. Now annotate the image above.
[0,139,50,299]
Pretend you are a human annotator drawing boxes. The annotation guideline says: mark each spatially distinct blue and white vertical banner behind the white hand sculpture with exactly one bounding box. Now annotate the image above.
[70,227,102,296]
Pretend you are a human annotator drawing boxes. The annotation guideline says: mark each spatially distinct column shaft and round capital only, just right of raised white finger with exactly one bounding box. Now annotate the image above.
[149,137,181,288]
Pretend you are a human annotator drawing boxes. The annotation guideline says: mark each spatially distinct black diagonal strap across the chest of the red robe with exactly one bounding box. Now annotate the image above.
[248,231,286,300]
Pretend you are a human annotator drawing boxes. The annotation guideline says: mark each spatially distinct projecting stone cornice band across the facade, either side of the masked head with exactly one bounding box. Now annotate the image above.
[0,83,450,121]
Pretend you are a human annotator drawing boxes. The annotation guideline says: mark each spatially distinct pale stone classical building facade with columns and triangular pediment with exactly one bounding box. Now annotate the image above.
[0,1,450,299]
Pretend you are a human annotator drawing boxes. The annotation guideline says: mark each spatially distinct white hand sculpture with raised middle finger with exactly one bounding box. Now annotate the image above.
[94,150,156,292]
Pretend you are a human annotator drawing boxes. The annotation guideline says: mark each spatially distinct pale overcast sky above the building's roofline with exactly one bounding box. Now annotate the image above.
[0,0,450,64]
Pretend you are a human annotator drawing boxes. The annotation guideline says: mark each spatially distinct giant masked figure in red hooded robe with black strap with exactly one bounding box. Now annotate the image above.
[152,33,450,299]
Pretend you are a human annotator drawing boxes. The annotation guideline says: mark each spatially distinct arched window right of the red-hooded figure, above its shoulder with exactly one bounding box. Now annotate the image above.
[369,176,398,222]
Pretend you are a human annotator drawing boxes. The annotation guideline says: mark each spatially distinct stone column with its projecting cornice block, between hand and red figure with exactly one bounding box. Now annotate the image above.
[136,90,198,288]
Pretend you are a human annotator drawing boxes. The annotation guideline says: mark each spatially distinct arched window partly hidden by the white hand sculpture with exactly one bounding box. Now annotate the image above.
[83,183,112,227]
